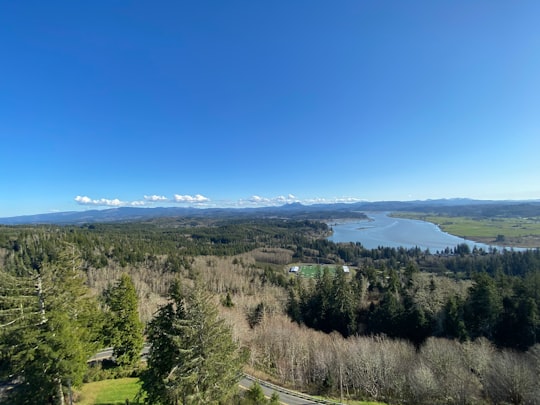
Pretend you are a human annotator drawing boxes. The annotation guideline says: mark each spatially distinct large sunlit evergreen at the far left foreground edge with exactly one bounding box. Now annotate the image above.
[2,246,98,404]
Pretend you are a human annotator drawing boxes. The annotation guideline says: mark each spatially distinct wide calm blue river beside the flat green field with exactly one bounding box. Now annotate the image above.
[328,212,501,253]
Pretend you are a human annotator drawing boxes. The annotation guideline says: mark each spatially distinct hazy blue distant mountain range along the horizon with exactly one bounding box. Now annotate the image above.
[0,198,540,225]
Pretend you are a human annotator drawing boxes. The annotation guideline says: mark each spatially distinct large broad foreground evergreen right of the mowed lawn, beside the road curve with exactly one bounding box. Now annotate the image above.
[141,282,241,405]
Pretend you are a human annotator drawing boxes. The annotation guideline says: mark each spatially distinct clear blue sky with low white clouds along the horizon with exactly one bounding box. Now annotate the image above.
[0,0,540,217]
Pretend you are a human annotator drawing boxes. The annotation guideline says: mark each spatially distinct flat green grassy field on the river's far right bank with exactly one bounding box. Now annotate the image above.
[392,212,540,247]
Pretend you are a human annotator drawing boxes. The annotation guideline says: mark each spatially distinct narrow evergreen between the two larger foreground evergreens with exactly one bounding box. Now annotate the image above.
[105,274,144,366]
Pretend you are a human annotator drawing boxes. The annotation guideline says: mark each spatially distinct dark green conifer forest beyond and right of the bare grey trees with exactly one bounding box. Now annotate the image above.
[0,219,540,349]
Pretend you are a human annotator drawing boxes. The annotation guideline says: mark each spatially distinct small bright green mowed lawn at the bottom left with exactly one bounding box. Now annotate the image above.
[75,378,141,405]
